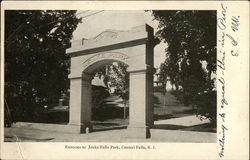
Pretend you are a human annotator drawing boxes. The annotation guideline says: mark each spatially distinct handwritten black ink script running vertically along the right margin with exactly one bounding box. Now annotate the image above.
[217,3,240,158]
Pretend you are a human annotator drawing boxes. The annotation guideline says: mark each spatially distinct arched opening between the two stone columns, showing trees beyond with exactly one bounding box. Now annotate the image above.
[83,59,129,132]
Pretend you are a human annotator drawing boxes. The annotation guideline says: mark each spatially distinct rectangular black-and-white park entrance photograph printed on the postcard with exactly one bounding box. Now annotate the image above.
[4,10,217,143]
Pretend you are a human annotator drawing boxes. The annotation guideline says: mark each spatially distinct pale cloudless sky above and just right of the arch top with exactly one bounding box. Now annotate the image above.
[73,10,166,68]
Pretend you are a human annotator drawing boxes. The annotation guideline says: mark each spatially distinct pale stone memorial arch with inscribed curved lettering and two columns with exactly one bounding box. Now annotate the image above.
[66,24,158,138]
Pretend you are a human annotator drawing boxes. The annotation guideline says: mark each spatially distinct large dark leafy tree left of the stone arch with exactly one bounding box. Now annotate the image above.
[4,10,81,121]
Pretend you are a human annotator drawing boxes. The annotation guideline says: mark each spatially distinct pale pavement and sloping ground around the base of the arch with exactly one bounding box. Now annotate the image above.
[4,93,216,142]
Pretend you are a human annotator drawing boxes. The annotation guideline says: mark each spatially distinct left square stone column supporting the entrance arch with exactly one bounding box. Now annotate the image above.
[69,74,93,133]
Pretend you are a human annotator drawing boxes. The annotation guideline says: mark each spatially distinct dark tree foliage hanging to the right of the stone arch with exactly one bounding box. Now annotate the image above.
[152,10,216,119]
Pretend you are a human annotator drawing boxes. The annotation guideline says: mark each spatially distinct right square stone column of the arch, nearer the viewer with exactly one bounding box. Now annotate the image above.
[128,66,154,138]
